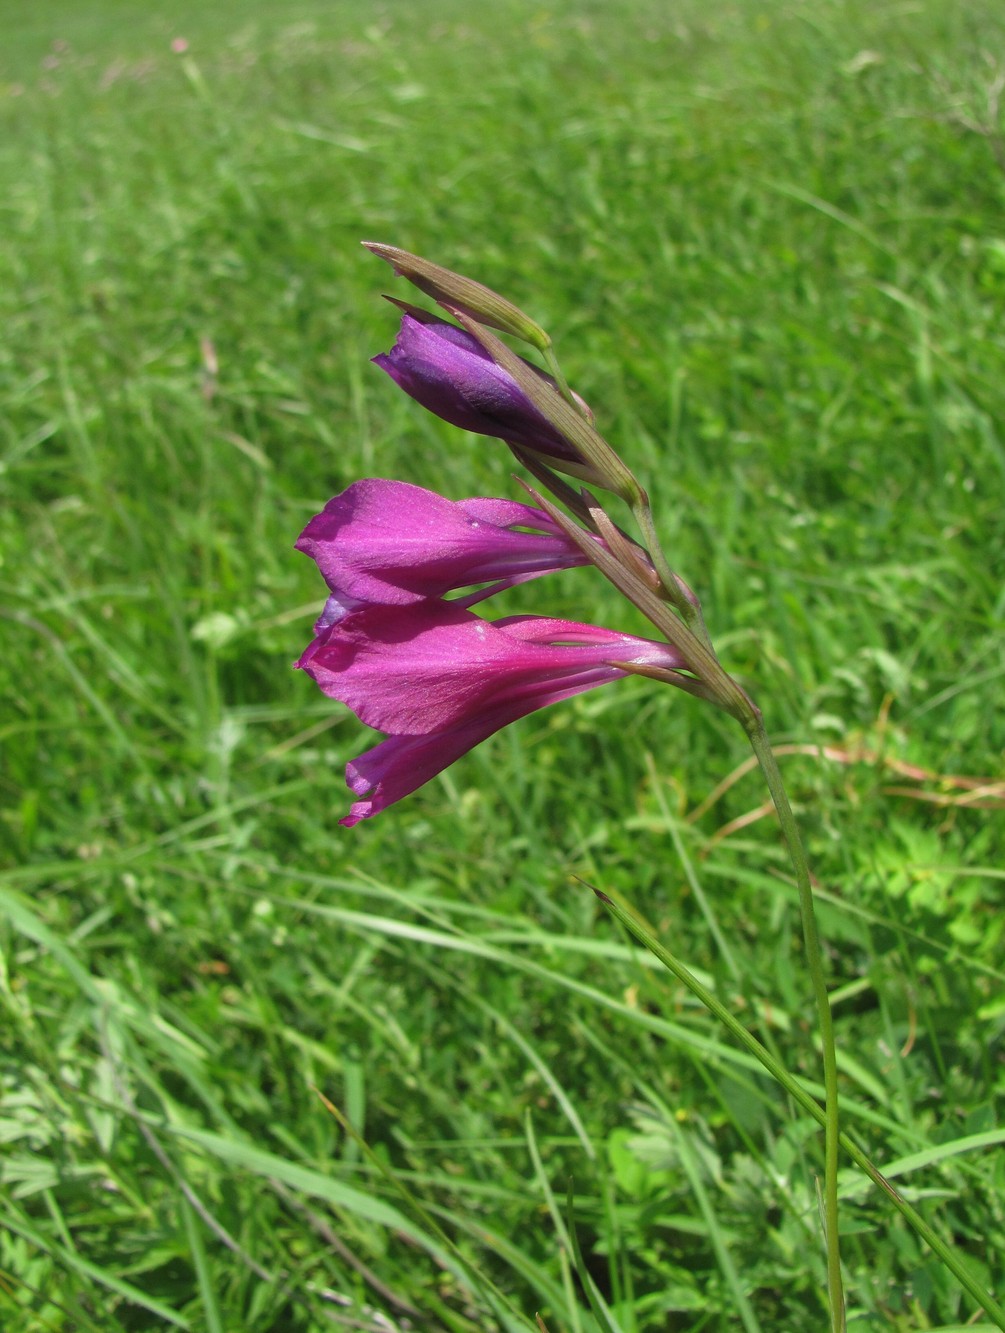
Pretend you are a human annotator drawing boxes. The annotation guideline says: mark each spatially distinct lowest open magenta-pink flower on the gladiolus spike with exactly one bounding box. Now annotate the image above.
[297,599,681,826]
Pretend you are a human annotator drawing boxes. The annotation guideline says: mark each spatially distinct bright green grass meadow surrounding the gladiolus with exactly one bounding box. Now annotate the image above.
[0,0,1005,1333]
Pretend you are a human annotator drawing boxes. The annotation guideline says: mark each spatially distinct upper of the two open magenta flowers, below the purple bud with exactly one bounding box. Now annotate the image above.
[297,479,586,633]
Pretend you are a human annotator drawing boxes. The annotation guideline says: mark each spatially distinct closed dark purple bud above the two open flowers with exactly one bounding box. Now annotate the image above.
[373,308,582,463]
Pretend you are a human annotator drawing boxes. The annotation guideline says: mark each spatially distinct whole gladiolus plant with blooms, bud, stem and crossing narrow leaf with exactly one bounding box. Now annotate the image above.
[287,250,1005,1333]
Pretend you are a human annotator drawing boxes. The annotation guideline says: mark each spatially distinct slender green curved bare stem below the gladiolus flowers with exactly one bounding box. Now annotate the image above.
[742,706,845,1333]
